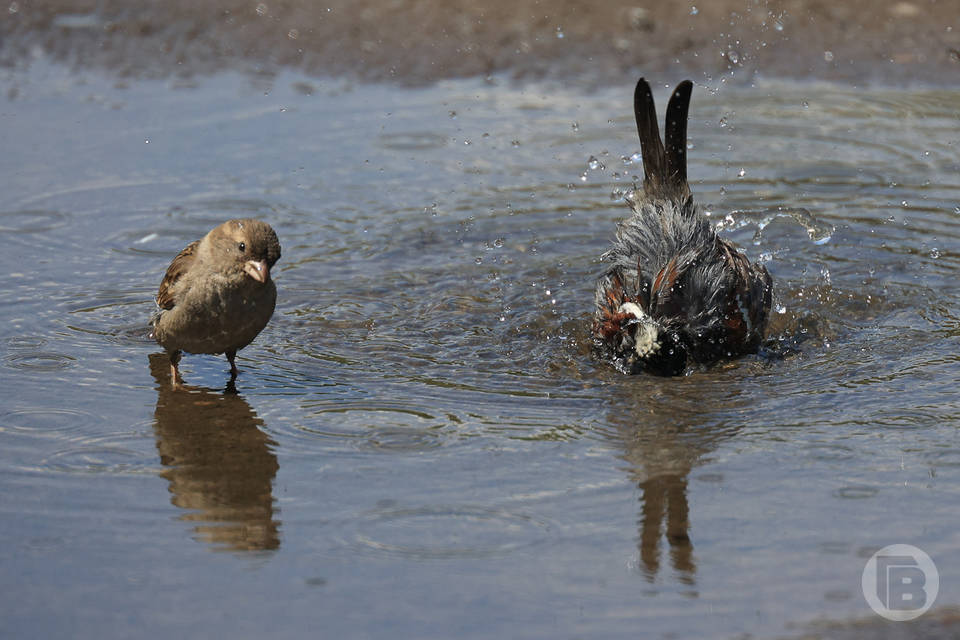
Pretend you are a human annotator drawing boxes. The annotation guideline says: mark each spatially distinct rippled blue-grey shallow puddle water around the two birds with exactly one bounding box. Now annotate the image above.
[0,58,960,638]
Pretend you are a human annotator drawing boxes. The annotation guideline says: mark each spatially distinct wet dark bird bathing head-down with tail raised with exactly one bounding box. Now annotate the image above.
[593,78,773,375]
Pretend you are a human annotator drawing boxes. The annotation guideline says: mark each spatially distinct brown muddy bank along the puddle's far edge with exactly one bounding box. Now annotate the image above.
[0,0,960,84]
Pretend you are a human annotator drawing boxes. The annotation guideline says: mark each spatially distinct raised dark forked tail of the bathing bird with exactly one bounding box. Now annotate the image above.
[633,78,693,202]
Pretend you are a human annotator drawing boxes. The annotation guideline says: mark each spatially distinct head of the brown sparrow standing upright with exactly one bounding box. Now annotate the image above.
[206,218,280,284]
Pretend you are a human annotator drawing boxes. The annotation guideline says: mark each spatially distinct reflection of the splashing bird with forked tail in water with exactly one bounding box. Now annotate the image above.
[610,381,735,585]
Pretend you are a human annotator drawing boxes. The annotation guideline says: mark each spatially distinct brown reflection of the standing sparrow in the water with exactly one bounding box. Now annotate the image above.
[150,353,280,551]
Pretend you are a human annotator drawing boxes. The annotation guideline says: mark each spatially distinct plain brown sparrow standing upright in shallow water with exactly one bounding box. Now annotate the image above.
[150,219,280,386]
